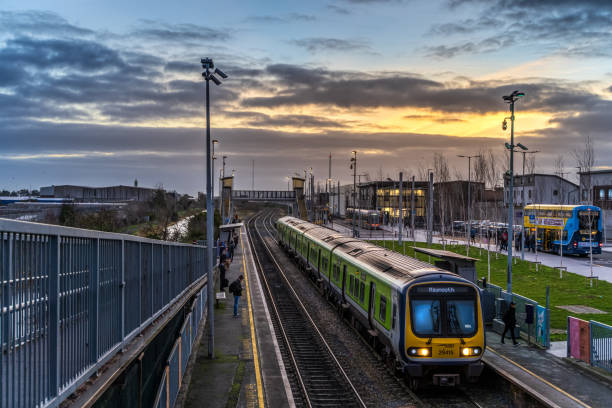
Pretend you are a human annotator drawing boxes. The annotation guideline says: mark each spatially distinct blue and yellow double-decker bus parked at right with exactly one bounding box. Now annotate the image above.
[523,204,603,255]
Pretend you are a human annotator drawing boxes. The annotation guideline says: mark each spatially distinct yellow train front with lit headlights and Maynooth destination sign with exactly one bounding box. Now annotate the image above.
[402,279,485,388]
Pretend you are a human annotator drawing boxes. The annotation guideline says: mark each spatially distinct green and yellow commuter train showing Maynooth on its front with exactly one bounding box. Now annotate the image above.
[277,217,485,388]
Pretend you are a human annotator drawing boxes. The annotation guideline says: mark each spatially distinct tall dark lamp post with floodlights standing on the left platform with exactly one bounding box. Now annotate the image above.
[200,58,227,358]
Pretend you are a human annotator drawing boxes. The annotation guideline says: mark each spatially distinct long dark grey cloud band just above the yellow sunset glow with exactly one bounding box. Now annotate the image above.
[242,64,600,113]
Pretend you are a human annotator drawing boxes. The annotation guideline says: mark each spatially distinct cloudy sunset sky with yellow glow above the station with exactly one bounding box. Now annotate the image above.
[0,0,612,193]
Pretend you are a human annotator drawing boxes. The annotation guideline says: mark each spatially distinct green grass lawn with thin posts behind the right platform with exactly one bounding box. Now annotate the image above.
[373,241,612,341]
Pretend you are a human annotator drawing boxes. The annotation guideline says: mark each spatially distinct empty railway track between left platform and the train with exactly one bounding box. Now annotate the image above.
[247,210,366,407]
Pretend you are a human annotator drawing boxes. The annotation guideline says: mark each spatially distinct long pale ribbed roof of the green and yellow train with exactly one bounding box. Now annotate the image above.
[279,217,458,285]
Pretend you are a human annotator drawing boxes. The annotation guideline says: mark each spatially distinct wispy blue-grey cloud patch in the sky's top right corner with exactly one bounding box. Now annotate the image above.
[425,0,612,58]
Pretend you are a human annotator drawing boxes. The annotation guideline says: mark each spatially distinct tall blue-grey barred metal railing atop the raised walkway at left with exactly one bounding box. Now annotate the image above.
[0,219,206,408]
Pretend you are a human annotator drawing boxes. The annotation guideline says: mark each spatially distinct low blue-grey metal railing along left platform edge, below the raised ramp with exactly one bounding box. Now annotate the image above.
[153,288,207,408]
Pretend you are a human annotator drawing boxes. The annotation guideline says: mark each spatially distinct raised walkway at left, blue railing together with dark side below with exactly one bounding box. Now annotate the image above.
[0,219,213,408]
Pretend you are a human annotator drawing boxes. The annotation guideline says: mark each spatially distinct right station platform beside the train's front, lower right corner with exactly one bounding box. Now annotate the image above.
[483,331,612,408]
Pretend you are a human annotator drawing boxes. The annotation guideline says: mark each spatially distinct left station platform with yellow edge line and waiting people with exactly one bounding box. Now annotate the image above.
[175,227,295,408]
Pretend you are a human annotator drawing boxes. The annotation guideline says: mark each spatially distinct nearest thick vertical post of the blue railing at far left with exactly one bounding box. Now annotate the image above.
[48,235,61,398]
